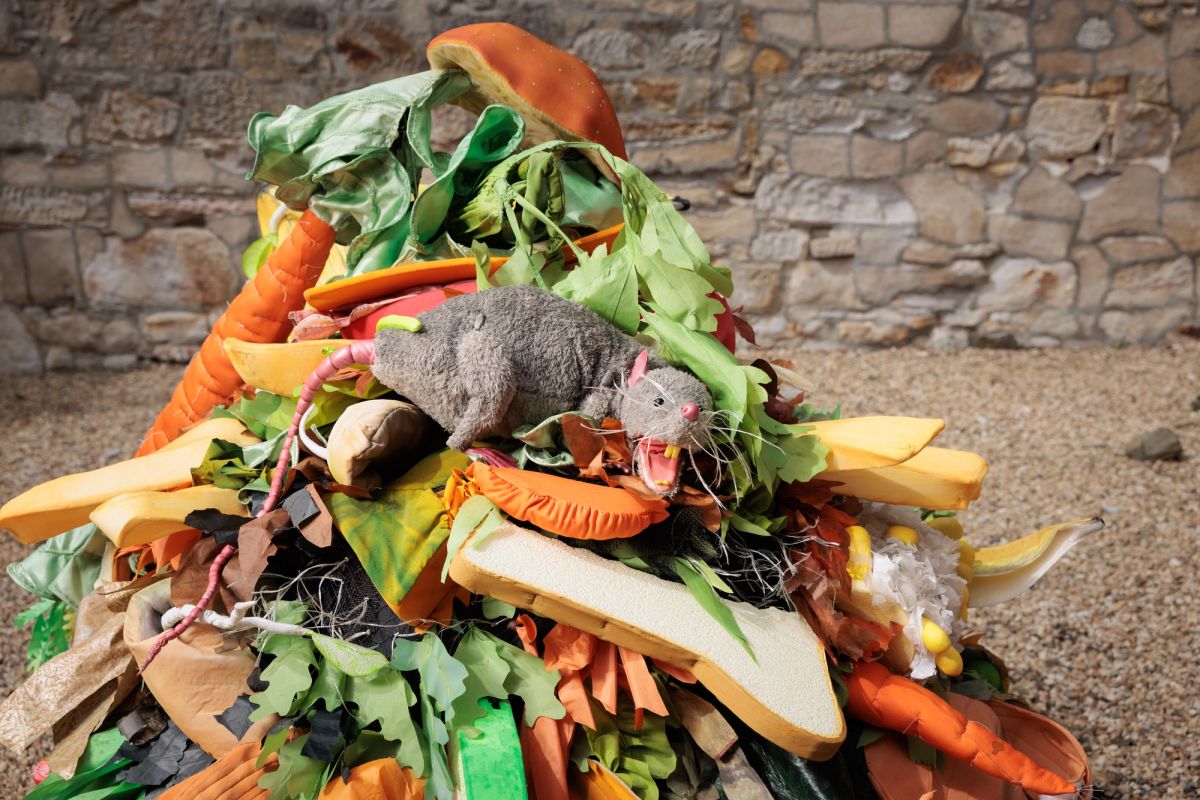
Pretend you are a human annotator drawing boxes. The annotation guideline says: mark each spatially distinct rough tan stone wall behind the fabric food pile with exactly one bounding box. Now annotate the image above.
[0,0,1200,372]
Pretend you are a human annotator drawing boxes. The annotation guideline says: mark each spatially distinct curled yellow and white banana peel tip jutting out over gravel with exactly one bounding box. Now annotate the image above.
[970,518,1104,608]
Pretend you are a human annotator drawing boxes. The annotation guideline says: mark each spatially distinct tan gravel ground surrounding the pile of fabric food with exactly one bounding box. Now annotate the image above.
[0,341,1200,799]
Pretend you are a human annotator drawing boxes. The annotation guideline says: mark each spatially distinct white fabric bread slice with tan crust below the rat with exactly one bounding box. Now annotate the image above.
[450,524,846,759]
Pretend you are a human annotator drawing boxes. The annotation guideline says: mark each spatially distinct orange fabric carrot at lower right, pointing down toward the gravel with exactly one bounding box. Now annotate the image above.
[845,662,1075,796]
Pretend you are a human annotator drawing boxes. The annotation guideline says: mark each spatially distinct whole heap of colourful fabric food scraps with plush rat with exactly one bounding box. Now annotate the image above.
[0,24,1100,800]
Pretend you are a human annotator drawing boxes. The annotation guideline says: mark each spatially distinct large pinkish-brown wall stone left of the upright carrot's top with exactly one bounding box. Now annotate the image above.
[83,228,238,308]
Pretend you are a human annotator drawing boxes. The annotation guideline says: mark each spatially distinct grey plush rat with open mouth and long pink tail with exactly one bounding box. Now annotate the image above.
[142,287,713,670]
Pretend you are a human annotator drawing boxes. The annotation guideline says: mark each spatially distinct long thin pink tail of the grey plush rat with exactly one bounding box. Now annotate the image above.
[138,339,374,673]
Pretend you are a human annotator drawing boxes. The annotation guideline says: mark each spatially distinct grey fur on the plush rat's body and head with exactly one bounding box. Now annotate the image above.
[372,287,713,450]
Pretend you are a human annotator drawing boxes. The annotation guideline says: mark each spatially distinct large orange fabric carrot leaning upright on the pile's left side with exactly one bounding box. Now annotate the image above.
[137,210,334,456]
